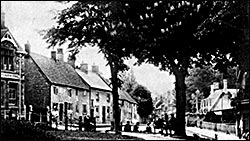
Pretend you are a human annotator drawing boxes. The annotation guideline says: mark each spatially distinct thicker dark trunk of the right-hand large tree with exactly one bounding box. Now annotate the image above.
[174,71,186,137]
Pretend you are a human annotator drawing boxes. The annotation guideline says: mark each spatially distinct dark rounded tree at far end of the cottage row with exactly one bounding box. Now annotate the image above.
[131,84,154,118]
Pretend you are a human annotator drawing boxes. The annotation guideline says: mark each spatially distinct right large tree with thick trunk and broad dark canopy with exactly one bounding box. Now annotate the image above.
[121,1,248,136]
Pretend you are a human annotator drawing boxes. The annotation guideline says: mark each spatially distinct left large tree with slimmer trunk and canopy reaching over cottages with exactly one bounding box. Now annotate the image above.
[41,1,136,134]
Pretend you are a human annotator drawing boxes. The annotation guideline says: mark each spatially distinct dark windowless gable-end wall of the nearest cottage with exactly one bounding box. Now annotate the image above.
[25,57,50,112]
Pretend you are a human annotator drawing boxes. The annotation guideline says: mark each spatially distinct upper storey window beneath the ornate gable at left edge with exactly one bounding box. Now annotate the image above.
[1,41,15,71]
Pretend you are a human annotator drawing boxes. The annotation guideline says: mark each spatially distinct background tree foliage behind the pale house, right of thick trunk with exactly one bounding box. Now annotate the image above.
[185,66,236,112]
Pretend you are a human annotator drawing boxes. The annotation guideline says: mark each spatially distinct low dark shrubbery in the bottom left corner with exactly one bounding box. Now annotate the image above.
[1,119,55,140]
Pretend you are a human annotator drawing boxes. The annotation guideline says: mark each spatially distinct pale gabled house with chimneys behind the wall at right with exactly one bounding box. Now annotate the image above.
[200,79,238,123]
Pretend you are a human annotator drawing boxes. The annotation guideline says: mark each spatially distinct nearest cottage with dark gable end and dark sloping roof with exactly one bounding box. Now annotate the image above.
[25,46,90,122]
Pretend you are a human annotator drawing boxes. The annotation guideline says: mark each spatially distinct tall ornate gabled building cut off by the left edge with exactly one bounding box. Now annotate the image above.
[1,7,25,118]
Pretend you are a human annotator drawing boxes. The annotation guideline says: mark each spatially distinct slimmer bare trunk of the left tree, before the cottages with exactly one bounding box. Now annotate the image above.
[110,63,121,134]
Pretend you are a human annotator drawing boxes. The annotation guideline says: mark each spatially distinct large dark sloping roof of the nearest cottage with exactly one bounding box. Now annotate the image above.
[30,53,88,89]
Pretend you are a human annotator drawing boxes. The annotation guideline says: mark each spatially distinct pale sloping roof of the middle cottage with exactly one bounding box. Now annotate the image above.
[76,69,112,92]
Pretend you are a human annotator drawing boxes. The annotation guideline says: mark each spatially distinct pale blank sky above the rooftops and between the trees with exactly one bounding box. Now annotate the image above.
[1,1,175,97]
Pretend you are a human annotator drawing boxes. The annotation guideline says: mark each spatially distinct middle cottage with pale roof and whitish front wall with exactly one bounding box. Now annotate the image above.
[76,63,113,123]
